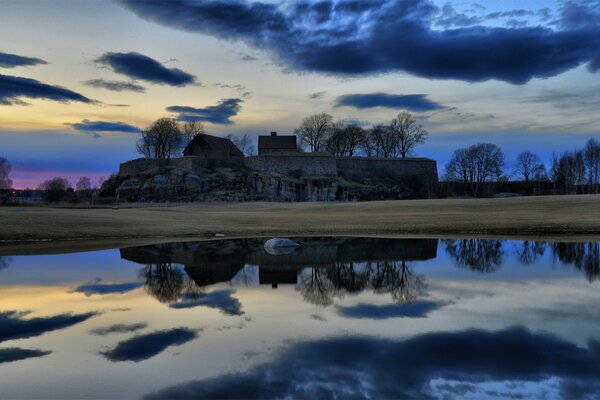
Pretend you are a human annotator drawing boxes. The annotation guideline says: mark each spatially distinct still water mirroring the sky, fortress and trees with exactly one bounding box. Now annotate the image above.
[0,237,600,399]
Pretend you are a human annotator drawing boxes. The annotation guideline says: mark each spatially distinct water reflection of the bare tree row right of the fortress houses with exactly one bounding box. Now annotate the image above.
[297,261,426,306]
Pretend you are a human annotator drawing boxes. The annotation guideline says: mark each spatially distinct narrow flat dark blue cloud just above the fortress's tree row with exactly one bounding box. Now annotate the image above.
[335,93,443,112]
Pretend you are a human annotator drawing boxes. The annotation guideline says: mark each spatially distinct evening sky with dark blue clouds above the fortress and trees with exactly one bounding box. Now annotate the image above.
[0,0,600,188]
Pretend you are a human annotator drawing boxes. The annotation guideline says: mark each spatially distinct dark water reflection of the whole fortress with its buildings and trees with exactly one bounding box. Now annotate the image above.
[121,238,437,304]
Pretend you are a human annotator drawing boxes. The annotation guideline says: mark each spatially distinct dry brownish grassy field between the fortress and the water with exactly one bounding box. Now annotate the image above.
[0,195,600,254]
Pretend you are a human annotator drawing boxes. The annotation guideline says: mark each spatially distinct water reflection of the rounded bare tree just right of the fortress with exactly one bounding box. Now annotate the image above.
[444,239,504,272]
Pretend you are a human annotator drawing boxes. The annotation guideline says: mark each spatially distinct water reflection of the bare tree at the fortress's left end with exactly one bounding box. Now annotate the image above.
[140,263,185,303]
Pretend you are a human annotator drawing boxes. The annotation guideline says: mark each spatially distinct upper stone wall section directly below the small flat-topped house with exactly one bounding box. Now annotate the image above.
[244,153,337,177]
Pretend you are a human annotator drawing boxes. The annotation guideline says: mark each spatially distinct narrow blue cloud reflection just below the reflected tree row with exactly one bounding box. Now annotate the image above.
[337,300,449,319]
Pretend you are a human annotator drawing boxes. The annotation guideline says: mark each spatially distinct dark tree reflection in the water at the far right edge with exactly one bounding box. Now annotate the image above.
[552,242,600,282]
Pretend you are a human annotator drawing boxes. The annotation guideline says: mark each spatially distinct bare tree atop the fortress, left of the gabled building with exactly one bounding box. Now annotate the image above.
[136,118,184,158]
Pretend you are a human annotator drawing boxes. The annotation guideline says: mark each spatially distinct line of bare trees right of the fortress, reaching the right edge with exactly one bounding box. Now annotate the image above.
[445,138,600,193]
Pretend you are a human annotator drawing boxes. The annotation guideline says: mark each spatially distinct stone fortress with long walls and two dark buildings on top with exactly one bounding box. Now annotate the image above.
[114,132,438,201]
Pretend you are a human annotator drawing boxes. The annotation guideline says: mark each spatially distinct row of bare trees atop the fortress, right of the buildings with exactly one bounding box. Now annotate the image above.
[294,112,428,158]
